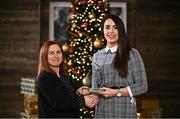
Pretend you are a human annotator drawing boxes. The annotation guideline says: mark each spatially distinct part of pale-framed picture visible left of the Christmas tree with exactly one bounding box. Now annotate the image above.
[49,2,72,44]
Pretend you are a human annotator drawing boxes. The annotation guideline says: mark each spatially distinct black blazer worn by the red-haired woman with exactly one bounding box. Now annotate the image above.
[37,71,79,118]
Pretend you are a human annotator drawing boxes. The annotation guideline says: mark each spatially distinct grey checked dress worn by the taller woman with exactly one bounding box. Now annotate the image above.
[92,48,148,118]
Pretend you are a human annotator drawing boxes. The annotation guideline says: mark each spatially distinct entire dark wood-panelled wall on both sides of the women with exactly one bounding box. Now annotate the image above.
[0,0,180,118]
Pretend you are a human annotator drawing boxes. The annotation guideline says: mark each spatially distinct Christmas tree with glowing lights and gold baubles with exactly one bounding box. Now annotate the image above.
[63,0,109,118]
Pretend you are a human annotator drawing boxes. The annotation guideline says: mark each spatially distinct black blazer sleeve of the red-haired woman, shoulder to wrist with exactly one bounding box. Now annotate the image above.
[37,72,77,110]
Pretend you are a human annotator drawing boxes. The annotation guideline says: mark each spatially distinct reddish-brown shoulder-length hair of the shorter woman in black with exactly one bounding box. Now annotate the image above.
[38,41,67,76]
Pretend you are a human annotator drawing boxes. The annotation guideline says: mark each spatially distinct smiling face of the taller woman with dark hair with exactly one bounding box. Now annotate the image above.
[103,18,119,47]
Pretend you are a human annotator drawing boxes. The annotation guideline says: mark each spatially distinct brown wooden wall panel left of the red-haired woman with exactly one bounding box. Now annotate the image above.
[0,0,40,118]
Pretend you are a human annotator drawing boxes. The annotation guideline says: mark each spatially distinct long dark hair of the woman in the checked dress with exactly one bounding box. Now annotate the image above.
[101,15,131,77]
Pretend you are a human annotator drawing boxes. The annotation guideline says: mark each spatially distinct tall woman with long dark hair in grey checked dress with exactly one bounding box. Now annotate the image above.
[92,15,148,118]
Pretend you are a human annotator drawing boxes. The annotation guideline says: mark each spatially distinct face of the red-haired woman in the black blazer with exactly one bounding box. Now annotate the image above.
[48,44,63,68]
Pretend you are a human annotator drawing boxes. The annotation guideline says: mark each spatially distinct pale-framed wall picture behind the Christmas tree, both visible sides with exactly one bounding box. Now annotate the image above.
[49,2,127,44]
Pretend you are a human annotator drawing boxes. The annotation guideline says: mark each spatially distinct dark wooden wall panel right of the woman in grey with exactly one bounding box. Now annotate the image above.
[135,0,180,117]
